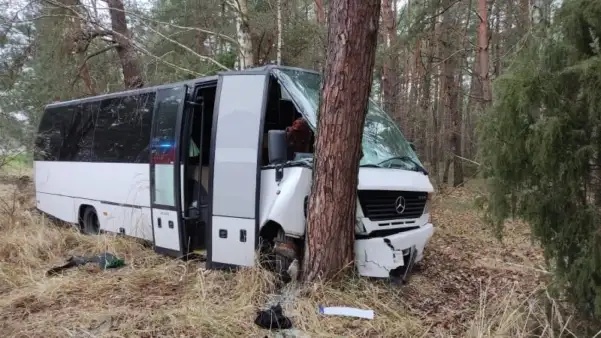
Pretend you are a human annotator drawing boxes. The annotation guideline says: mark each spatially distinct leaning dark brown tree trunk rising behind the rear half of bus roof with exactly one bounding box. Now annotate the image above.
[107,0,144,88]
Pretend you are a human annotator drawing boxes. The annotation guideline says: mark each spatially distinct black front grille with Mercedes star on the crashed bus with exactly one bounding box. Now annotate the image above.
[357,190,428,221]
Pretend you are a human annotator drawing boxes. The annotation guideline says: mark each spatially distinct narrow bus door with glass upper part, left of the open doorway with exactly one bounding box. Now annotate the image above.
[150,85,188,257]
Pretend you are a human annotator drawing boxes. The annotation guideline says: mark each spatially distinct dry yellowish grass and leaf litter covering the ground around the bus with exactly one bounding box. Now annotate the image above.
[0,173,584,337]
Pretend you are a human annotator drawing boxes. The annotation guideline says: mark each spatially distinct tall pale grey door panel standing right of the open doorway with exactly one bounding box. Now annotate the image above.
[206,70,269,269]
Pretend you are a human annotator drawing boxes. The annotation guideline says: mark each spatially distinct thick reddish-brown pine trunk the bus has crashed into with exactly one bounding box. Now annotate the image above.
[303,0,380,281]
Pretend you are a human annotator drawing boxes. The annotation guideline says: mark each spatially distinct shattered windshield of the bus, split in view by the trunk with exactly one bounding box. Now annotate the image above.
[274,68,425,172]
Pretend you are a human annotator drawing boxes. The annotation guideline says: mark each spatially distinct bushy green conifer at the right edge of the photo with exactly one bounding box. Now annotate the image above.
[479,0,601,317]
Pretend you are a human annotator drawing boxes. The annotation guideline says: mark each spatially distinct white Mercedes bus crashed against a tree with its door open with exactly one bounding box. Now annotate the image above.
[35,65,433,277]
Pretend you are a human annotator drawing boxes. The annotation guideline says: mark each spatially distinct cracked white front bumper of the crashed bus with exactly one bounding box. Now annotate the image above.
[355,223,434,278]
